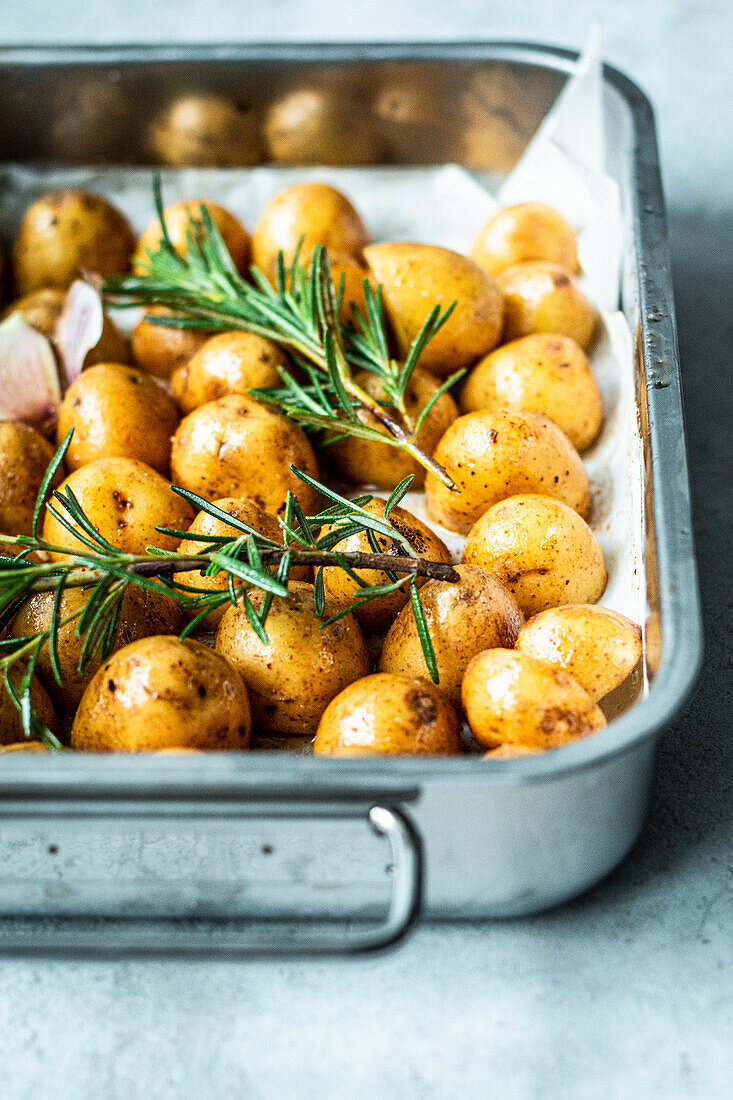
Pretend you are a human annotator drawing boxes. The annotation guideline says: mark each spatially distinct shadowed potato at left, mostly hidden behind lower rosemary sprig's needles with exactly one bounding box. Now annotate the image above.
[11,584,183,711]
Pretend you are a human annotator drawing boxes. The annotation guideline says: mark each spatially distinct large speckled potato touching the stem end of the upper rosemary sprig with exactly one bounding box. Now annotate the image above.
[425,409,591,535]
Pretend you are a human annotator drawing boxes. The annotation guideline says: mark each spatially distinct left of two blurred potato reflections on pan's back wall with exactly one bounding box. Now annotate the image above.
[151,96,261,168]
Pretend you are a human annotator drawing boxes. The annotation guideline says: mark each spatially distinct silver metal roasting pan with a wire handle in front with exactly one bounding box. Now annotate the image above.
[0,43,701,957]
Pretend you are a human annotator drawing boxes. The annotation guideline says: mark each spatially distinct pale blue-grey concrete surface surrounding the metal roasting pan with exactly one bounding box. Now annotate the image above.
[0,0,733,1100]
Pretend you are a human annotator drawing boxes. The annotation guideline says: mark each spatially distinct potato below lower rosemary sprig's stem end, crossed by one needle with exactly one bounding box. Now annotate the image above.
[379,565,524,705]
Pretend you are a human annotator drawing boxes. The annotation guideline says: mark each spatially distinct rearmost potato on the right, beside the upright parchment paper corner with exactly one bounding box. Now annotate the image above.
[471,202,579,276]
